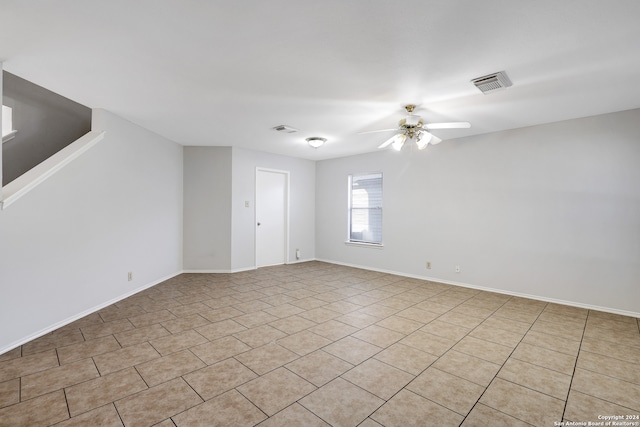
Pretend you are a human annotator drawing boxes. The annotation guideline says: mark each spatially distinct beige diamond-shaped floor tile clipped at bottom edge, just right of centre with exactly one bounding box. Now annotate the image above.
[299,378,384,427]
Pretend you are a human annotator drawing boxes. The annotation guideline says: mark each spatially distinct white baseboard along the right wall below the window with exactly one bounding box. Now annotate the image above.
[316,258,640,318]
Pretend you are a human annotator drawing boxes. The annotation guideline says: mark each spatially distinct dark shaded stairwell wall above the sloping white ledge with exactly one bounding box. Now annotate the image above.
[2,71,91,186]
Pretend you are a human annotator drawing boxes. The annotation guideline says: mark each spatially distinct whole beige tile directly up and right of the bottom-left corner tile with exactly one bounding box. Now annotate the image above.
[65,368,147,417]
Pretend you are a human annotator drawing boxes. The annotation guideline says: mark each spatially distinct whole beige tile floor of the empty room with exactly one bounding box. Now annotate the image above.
[0,262,640,427]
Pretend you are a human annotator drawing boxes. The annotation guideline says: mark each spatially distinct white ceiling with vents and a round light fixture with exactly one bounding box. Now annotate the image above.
[0,0,640,160]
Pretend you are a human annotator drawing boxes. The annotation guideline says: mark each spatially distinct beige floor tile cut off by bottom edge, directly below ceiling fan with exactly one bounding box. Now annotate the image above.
[371,389,463,427]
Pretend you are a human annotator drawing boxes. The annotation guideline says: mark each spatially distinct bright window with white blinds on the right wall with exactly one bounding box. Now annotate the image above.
[348,173,382,245]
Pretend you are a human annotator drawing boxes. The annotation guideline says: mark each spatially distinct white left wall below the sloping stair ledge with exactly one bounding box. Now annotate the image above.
[0,110,182,353]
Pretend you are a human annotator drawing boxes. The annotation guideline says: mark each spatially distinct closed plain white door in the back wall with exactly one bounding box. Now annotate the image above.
[256,169,289,267]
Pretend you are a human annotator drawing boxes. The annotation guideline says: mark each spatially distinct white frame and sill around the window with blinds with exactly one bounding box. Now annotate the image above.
[345,172,384,248]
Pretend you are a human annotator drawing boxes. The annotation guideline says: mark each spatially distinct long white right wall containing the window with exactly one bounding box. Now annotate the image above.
[316,110,640,316]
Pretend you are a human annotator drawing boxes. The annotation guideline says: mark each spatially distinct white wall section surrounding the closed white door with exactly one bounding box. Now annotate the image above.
[231,148,315,271]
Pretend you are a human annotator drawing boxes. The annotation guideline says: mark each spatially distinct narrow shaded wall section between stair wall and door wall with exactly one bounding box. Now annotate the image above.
[183,147,231,272]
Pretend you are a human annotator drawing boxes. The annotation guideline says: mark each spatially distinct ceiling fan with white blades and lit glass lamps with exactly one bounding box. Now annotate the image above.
[362,104,471,151]
